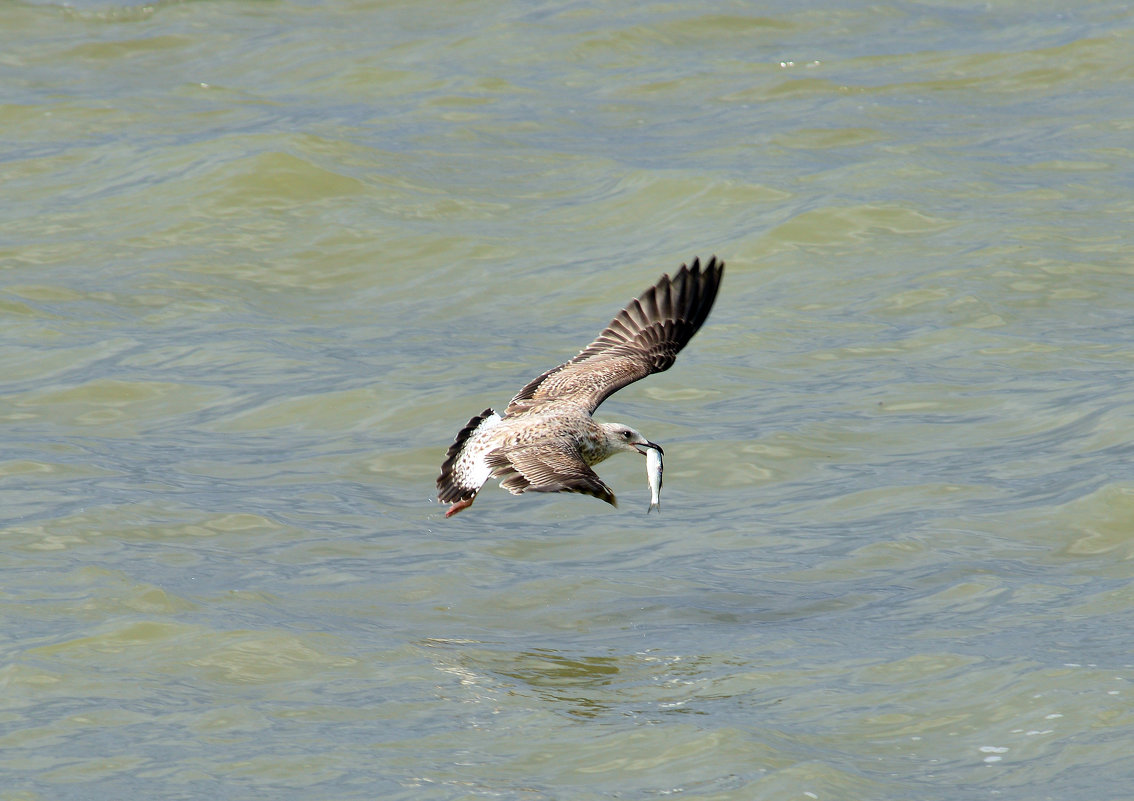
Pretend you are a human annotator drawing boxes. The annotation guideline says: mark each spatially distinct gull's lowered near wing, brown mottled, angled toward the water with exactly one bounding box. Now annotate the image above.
[485,440,618,506]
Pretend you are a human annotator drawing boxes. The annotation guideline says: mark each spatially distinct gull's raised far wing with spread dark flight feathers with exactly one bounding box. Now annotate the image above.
[505,256,725,415]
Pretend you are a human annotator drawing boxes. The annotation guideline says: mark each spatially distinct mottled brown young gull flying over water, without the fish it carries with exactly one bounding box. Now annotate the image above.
[437,256,725,517]
